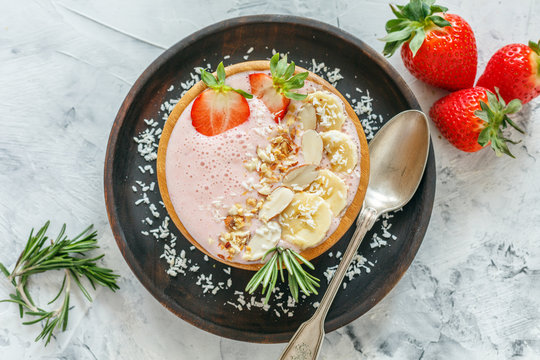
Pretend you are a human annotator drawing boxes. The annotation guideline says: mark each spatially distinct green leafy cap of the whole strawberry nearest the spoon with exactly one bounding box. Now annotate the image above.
[474,88,525,158]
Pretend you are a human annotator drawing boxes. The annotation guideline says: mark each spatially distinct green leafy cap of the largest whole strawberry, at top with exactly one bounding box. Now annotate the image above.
[381,0,452,57]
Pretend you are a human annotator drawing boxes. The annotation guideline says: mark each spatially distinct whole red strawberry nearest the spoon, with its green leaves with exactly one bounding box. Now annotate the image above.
[429,86,523,157]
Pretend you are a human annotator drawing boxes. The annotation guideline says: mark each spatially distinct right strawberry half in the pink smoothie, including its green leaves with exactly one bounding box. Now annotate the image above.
[249,53,308,123]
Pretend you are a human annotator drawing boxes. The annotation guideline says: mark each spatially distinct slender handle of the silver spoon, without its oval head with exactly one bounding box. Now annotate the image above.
[279,207,379,360]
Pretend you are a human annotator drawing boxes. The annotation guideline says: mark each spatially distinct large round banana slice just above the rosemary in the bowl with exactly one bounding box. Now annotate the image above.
[279,192,332,250]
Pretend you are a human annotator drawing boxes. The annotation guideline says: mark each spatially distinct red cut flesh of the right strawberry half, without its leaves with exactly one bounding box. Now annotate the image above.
[249,73,291,123]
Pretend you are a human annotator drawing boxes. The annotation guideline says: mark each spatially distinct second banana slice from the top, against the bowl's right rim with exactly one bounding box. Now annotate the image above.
[320,130,358,173]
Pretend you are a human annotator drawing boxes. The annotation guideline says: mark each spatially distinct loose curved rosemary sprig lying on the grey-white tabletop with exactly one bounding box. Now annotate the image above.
[0,221,119,346]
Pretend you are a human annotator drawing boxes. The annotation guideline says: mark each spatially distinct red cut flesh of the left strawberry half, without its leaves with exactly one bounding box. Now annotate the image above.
[191,89,250,136]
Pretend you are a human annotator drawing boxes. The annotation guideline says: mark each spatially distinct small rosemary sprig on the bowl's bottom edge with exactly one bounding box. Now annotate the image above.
[246,246,320,304]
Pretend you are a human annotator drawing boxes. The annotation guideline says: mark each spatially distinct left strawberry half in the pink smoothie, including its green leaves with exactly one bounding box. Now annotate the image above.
[191,62,253,136]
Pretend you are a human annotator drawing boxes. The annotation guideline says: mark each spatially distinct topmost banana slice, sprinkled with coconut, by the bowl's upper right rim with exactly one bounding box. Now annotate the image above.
[306,91,345,131]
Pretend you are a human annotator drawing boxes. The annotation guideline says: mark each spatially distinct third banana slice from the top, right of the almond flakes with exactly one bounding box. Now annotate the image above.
[306,169,349,216]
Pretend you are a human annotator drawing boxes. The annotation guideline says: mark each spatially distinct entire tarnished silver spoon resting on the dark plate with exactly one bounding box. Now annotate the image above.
[280,110,429,360]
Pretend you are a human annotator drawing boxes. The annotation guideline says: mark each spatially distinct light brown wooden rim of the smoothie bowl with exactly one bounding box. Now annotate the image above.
[156,60,369,271]
